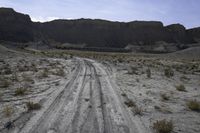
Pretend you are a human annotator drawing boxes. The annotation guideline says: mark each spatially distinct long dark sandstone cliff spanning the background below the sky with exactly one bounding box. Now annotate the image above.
[0,8,199,48]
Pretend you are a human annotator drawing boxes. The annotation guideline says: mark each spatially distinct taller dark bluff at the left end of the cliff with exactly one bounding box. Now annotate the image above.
[0,8,33,42]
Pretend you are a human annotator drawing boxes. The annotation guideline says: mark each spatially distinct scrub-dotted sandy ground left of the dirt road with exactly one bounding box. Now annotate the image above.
[0,49,74,129]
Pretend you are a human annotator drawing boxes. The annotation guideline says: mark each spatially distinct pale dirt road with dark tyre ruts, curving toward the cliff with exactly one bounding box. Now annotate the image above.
[2,58,147,133]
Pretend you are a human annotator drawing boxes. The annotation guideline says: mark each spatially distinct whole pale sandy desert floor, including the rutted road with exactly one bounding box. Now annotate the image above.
[0,47,200,133]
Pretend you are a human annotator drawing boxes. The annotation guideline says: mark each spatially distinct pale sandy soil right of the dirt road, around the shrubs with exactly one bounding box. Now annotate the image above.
[112,59,200,133]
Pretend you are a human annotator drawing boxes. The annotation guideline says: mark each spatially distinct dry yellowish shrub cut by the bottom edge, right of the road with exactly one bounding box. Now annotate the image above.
[153,119,174,133]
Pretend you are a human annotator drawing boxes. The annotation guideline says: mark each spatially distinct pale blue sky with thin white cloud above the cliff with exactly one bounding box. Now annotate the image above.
[0,0,200,28]
